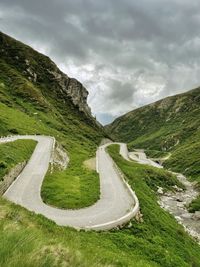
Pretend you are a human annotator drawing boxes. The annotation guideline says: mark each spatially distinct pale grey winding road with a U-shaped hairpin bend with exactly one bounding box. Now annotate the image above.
[0,136,139,230]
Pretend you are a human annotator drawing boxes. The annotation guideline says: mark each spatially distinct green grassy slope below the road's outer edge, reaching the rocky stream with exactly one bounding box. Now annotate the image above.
[0,146,200,267]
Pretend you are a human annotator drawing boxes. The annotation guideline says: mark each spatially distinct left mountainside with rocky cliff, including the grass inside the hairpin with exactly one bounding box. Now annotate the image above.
[0,33,104,208]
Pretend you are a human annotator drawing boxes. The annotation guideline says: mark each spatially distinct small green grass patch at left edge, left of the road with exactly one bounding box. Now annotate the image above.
[0,140,37,181]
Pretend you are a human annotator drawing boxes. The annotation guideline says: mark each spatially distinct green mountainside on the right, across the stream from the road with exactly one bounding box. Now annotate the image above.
[106,88,200,211]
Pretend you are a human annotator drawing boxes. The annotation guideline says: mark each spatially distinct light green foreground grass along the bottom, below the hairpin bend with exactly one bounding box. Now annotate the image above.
[0,199,155,267]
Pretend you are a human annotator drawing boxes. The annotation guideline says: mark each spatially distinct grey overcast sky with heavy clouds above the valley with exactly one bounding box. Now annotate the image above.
[0,0,200,124]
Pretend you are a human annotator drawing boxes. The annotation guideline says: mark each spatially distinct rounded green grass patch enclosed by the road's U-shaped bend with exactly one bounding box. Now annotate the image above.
[41,158,100,209]
